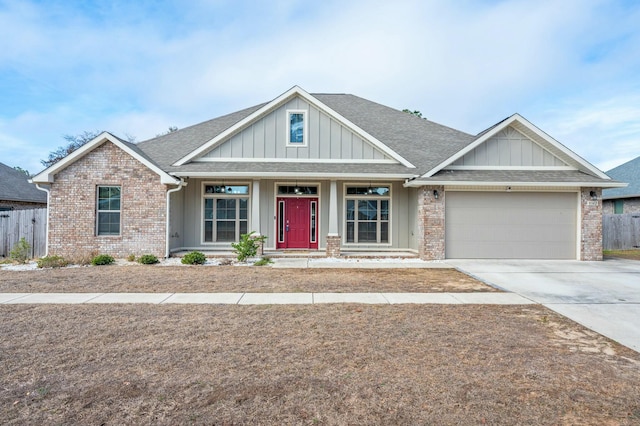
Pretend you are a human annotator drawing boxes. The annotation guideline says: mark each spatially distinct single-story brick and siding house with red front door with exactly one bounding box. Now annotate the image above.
[32,86,621,260]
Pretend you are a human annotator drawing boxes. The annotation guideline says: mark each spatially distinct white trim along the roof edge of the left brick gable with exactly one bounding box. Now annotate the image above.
[31,132,180,185]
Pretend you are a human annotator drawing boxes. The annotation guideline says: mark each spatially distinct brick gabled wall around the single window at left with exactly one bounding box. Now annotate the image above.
[49,142,167,258]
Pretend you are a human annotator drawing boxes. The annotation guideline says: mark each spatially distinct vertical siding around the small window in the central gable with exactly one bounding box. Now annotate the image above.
[202,98,391,160]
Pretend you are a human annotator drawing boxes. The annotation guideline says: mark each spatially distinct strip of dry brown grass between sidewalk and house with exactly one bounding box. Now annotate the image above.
[0,265,496,293]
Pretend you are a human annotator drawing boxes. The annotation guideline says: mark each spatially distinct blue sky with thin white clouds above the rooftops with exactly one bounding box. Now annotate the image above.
[0,0,640,173]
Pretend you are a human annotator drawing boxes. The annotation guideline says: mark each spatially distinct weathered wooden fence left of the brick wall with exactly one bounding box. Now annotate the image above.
[0,209,47,258]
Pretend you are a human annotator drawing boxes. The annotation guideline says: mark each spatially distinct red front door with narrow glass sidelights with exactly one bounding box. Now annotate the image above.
[277,198,318,249]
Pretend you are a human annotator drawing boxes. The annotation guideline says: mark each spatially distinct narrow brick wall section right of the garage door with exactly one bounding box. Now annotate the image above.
[580,188,602,260]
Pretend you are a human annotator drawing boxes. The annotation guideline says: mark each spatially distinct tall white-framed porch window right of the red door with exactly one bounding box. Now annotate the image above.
[345,185,391,244]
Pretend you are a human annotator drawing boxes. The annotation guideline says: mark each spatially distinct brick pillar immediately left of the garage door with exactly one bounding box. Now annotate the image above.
[418,186,445,260]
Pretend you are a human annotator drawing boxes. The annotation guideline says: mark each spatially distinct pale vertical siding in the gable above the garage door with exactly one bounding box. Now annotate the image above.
[453,127,567,167]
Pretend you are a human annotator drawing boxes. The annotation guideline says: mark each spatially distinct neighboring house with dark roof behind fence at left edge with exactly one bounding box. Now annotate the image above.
[0,163,47,211]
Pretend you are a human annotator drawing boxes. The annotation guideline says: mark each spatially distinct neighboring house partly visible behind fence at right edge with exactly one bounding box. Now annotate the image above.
[602,157,640,214]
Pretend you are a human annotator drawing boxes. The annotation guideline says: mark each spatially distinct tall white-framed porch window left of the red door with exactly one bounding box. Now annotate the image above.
[202,184,249,243]
